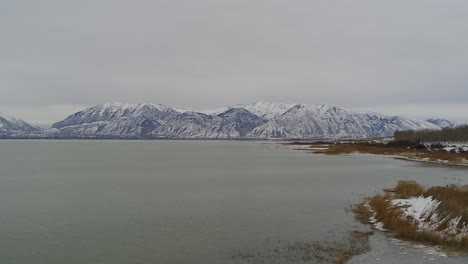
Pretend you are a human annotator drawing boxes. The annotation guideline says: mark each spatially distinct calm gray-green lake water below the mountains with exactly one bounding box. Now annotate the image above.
[0,140,468,264]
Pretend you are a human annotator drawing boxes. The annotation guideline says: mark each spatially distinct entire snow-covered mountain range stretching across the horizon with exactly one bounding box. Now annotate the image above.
[0,101,456,139]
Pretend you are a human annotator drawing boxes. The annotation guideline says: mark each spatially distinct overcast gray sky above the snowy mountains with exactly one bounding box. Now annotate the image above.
[0,0,468,125]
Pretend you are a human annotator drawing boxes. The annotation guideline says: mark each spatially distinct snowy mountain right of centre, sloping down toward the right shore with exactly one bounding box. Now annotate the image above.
[251,104,440,139]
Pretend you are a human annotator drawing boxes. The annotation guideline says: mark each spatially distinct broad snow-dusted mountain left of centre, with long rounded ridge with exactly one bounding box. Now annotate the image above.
[44,103,265,139]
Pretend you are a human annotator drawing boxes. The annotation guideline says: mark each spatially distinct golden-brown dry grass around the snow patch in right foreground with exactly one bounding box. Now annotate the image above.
[355,181,468,249]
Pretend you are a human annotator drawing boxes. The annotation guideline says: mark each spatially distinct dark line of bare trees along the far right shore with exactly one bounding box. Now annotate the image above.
[394,126,468,142]
